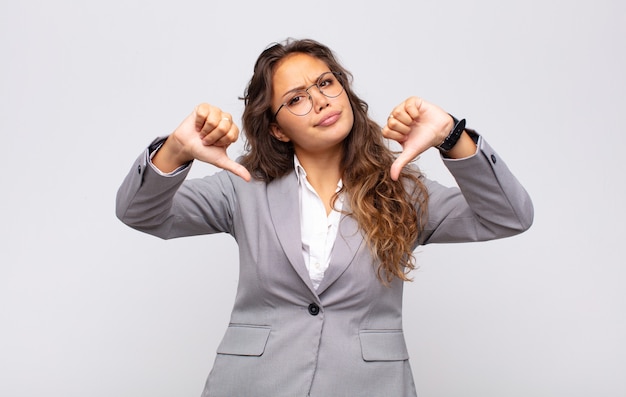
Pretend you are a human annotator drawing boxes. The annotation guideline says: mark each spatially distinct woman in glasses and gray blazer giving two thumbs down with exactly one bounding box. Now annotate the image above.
[117,40,533,397]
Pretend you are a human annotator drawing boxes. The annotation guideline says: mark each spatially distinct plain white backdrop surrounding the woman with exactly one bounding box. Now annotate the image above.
[0,0,626,397]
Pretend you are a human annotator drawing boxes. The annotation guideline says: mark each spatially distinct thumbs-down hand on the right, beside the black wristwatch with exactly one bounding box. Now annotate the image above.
[382,97,454,181]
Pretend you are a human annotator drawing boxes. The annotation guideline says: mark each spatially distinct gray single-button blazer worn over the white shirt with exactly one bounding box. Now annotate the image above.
[117,135,533,397]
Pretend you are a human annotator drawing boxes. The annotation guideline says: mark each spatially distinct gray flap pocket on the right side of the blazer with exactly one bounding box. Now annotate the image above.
[359,330,409,361]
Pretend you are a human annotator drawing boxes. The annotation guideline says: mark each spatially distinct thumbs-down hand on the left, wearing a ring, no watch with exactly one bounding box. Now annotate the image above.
[152,103,250,181]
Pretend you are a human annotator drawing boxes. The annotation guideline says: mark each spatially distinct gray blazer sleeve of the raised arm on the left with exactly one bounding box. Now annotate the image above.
[116,140,235,239]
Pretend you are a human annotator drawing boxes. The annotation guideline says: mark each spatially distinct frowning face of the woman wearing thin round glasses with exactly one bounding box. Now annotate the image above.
[270,53,354,157]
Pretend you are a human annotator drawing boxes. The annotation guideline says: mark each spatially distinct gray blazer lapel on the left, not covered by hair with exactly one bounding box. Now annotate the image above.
[267,172,315,293]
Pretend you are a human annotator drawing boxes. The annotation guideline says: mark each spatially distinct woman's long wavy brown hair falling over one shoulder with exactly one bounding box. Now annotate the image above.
[241,39,428,284]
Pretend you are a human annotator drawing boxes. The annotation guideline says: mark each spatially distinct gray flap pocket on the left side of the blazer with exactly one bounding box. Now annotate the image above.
[217,324,270,357]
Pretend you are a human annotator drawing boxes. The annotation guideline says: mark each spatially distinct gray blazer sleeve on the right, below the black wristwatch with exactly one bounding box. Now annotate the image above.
[418,137,534,244]
